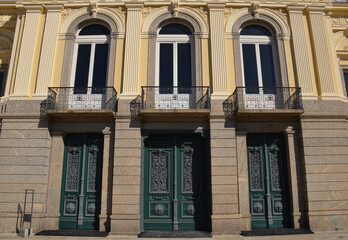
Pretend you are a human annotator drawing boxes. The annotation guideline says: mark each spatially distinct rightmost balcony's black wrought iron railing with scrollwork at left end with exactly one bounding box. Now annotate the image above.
[223,87,303,115]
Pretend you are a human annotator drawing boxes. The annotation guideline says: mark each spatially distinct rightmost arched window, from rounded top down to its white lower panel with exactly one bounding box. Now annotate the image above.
[240,25,280,94]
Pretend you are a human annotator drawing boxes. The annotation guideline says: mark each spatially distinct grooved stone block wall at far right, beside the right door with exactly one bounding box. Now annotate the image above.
[301,118,348,230]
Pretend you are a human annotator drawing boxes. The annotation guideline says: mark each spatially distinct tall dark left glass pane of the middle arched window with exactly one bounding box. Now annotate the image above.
[159,43,173,93]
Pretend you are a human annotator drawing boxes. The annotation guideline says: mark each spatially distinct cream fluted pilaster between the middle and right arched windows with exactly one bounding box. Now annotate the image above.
[208,4,229,100]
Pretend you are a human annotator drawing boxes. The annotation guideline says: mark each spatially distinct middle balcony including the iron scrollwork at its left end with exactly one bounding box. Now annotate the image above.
[131,86,210,115]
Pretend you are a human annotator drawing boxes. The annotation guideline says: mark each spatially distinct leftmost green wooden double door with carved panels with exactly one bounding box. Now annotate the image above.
[59,134,103,230]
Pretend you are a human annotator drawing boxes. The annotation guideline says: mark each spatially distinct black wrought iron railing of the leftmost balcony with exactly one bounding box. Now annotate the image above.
[46,87,117,112]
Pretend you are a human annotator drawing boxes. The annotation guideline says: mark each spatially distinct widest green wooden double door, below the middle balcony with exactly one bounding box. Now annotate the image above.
[144,135,208,230]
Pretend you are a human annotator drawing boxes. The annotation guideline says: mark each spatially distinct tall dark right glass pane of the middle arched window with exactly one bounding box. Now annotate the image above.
[178,43,192,93]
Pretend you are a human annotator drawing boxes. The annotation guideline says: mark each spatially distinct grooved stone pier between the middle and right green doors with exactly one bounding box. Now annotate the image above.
[210,114,240,234]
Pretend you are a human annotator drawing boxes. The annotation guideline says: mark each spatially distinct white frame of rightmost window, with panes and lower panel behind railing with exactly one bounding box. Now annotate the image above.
[240,25,283,109]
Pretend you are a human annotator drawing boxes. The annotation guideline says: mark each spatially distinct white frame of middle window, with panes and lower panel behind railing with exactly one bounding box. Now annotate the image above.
[155,24,196,109]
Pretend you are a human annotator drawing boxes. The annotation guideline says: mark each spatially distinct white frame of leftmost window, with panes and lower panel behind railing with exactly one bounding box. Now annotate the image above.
[69,24,110,109]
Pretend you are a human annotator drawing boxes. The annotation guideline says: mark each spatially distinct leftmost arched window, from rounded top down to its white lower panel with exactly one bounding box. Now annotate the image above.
[71,24,110,94]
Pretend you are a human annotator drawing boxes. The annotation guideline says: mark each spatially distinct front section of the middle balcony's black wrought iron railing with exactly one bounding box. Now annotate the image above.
[140,86,210,109]
